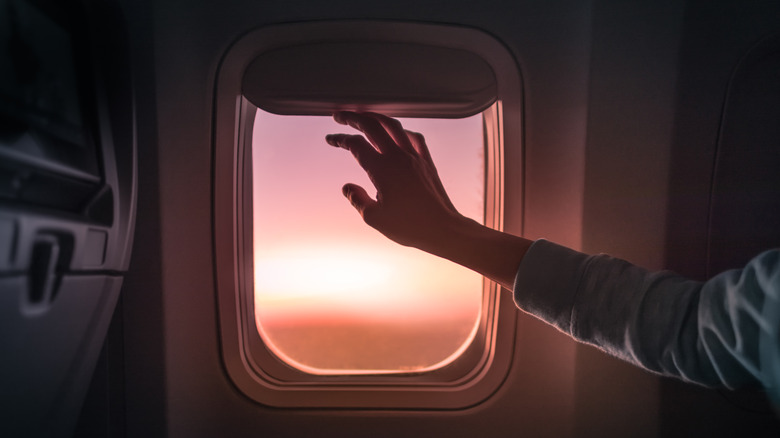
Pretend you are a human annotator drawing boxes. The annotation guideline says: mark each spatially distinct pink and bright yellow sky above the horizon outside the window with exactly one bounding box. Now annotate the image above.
[253,110,484,372]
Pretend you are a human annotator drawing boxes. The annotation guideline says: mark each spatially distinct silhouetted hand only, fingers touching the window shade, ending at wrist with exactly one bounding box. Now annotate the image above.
[326,111,464,252]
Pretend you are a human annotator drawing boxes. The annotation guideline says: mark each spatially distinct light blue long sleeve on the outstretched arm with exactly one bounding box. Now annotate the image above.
[514,240,780,403]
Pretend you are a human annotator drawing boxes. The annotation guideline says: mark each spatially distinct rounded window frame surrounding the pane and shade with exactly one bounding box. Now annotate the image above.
[214,21,521,409]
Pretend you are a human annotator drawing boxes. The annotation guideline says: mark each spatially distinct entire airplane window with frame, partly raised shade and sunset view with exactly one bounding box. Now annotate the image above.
[213,21,523,409]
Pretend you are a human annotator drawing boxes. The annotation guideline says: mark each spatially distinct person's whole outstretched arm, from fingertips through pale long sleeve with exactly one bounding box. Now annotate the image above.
[327,112,780,401]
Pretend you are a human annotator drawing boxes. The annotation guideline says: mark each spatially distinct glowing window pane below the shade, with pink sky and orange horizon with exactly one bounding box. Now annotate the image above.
[252,110,485,374]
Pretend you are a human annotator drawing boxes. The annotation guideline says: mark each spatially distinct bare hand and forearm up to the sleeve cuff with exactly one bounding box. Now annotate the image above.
[326,111,531,289]
